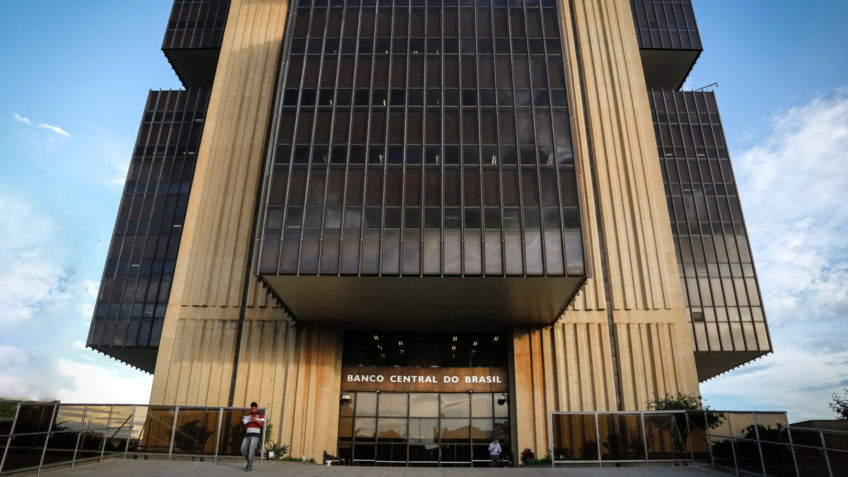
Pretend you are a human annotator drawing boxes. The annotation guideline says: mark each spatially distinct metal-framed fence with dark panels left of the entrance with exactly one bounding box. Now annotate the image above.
[0,402,265,474]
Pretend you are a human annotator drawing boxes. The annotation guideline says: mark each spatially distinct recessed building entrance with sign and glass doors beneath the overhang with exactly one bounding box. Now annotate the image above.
[338,334,510,466]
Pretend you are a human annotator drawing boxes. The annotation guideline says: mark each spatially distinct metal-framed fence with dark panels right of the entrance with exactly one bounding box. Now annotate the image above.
[548,411,848,477]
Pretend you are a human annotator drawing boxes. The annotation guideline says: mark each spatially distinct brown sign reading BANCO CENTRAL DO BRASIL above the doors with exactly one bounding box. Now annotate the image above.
[342,366,509,392]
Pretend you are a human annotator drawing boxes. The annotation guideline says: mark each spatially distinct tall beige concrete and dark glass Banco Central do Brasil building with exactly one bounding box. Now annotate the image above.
[88,0,771,465]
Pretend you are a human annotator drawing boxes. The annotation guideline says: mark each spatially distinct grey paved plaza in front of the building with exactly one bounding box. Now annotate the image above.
[43,460,727,477]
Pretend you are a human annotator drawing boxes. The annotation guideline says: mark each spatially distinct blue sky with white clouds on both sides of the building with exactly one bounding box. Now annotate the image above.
[0,0,848,419]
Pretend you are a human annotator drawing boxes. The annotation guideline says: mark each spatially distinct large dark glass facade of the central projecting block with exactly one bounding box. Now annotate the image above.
[259,0,584,276]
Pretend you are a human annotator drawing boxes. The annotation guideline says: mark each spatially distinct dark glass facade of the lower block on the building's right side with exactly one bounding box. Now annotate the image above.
[649,90,771,356]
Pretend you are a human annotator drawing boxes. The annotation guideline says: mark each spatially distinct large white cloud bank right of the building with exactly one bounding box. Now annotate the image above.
[735,89,848,324]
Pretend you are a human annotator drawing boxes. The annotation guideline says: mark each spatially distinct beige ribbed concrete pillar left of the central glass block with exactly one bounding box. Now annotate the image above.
[150,0,341,459]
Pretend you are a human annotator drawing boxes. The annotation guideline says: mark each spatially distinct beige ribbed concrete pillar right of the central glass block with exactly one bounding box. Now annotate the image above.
[511,0,698,455]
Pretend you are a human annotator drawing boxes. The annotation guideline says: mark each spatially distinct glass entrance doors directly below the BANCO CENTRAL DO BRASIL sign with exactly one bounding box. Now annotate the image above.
[338,392,509,466]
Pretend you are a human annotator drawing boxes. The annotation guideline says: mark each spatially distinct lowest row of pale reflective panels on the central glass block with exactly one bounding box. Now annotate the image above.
[259,229,585,276]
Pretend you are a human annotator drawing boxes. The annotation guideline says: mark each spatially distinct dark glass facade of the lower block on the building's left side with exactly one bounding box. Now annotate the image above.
[87,89,209,373]
